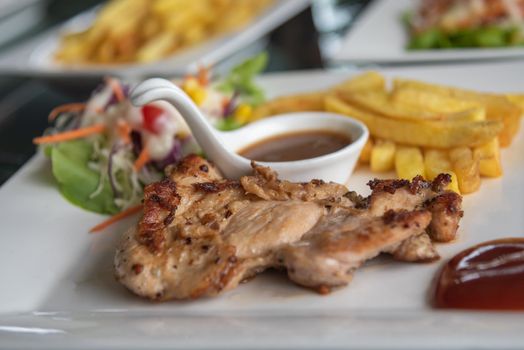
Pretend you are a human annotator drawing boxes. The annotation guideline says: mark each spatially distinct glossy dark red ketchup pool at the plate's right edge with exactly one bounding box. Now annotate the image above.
[434,238,524,310]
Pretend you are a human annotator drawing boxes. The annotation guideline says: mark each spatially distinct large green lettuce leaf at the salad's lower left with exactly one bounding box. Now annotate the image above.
[50,140,119,214]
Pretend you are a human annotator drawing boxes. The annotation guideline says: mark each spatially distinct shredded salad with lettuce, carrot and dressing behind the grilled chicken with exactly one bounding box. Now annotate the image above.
[34,53,267,214]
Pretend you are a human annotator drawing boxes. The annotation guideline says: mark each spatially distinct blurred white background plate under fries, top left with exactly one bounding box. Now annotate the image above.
[0,0,309,79]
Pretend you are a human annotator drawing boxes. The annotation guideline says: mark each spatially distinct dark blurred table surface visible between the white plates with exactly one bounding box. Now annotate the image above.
[0,0,368,184]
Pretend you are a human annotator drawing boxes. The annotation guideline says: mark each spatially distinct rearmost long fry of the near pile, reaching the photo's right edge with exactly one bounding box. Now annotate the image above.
[393,79,522,147]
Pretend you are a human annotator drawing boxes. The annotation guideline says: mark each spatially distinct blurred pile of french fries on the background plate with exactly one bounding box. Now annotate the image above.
[55,0,272,64]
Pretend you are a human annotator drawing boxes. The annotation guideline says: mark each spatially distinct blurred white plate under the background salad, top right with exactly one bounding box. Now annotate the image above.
[332,0,524,63]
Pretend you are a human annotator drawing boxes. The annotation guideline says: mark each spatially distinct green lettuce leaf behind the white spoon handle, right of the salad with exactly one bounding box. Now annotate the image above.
[217,52,268,106]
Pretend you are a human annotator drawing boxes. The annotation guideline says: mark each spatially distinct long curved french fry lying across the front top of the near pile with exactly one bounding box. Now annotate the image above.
[325,96,502,148]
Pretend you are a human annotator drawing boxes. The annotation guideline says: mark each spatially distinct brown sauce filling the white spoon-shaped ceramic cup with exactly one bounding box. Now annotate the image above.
[238,130,351,162]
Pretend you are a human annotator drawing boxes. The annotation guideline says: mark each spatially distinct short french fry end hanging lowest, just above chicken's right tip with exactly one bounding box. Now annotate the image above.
[449,147,480,194]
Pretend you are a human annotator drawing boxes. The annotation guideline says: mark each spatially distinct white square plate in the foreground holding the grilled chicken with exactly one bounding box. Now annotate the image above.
[0,63,524,349]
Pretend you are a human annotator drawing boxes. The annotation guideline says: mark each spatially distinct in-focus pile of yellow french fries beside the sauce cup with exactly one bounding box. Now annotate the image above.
[253,72,524,194]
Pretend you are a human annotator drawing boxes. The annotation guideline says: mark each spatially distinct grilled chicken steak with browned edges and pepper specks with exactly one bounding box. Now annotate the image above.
[115,156,462,300]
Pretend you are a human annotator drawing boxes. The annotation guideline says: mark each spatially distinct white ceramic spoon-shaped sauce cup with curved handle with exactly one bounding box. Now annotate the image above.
[131,78,369,183]
